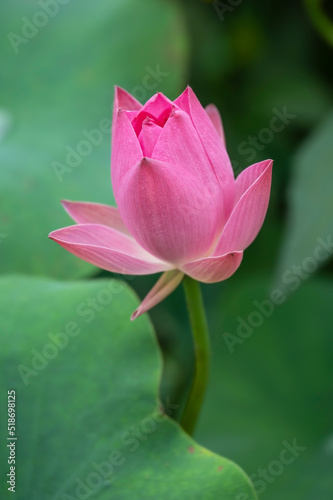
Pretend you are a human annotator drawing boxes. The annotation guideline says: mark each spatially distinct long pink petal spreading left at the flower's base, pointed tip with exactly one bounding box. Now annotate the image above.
[49,224,172,274]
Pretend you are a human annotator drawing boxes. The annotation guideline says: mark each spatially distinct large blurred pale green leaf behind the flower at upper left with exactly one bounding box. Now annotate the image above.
[0,0,188,278]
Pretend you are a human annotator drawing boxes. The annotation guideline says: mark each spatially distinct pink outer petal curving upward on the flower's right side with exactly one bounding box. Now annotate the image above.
[214,160,273,255]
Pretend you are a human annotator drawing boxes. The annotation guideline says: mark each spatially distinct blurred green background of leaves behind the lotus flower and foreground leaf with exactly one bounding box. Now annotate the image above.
[0,0,333,500]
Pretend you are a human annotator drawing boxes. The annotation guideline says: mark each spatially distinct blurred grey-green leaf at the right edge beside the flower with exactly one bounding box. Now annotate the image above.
[276,109,333,290]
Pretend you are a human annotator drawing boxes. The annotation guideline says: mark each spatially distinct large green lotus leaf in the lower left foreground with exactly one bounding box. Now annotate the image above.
[0,277,255,500]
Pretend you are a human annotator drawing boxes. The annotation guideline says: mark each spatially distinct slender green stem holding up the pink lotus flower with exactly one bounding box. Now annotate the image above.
[181,276,210,435]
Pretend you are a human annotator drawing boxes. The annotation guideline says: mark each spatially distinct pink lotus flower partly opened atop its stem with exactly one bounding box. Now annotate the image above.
[50,87,273,319]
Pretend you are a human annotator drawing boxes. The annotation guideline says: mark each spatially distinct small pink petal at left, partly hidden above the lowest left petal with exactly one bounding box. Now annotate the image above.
[61,200,130,235]
